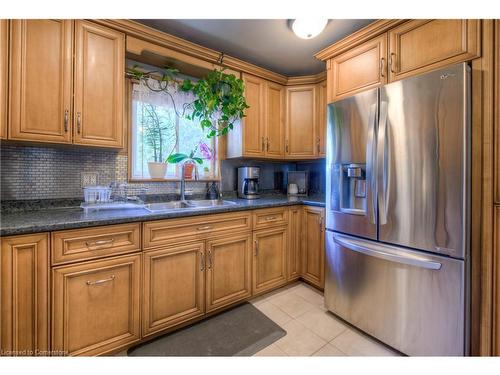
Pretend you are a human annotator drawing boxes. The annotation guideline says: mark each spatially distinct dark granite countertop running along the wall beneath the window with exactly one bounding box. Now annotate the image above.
[0,195,325,236]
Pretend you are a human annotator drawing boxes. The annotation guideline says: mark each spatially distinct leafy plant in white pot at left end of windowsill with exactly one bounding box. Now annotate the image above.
[142,104,177,179]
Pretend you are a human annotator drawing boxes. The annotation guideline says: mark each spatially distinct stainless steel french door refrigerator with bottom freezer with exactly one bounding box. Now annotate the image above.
[325,63,470,355]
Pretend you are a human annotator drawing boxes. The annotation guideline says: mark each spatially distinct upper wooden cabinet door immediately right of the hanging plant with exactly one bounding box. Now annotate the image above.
[241,74,266,157]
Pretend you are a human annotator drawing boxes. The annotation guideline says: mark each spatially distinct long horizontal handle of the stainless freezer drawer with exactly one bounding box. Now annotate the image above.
[333,233,442,270]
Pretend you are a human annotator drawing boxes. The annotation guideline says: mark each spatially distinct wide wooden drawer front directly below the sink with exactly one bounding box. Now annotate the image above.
[143,212,252,249]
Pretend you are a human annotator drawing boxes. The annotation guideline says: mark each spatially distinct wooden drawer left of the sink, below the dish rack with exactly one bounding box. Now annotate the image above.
[52,223,141,265]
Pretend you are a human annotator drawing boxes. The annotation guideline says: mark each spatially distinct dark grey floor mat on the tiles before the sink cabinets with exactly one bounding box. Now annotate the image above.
[128,302,286,357]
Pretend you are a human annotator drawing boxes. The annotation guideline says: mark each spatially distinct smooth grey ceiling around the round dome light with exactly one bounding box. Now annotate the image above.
[136,19,374,76]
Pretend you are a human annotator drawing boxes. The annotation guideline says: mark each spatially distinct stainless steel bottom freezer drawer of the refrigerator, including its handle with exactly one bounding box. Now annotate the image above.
[325,231,465,356]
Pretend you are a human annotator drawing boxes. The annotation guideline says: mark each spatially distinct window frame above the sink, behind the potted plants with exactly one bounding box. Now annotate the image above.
[123,78,223,183]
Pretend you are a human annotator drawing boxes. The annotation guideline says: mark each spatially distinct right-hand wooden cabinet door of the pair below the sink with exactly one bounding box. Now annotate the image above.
[206,233,252,312]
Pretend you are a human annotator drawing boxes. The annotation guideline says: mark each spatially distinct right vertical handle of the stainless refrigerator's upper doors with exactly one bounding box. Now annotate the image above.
[376,101,389,225]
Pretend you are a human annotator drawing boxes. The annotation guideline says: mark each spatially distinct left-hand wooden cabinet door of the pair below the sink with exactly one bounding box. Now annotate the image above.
[142,242,205,335]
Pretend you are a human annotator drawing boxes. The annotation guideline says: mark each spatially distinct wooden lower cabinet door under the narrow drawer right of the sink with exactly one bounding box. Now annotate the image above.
[252,227,288,294]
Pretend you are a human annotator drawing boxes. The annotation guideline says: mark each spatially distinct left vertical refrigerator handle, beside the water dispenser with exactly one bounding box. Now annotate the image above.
[366,104,377,224]
